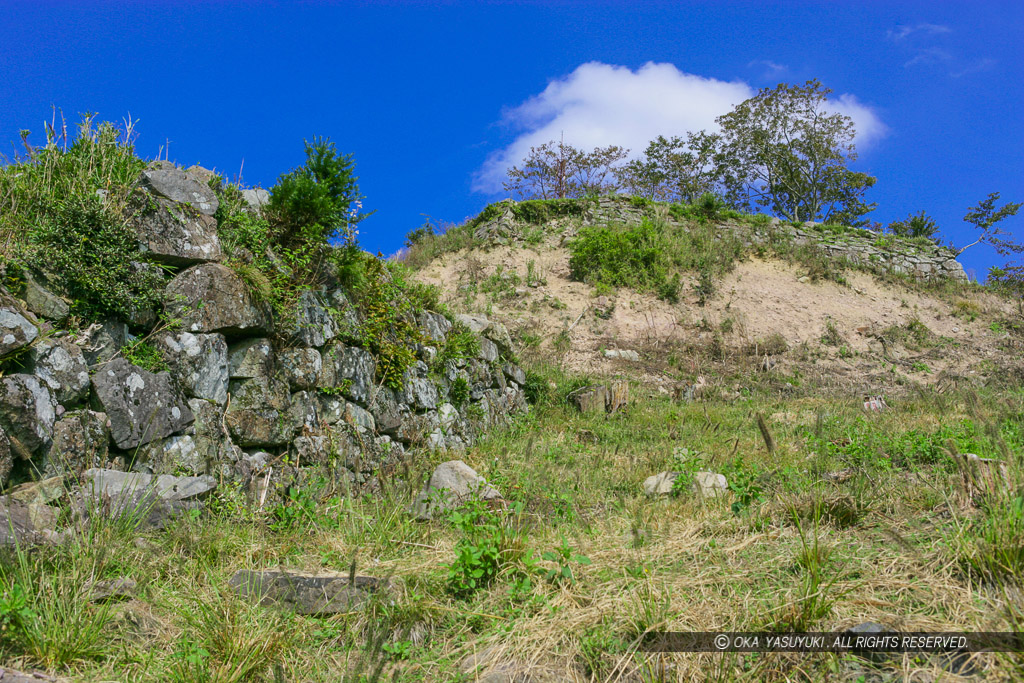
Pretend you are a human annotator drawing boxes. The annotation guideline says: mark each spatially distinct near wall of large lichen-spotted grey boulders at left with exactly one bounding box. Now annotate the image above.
[0,164,526,499]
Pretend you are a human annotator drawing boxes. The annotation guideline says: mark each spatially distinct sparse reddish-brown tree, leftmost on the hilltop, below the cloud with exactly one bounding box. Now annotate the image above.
[503,140,629,200]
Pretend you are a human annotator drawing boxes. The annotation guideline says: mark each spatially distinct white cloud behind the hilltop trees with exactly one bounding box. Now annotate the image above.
[473,61,886,193]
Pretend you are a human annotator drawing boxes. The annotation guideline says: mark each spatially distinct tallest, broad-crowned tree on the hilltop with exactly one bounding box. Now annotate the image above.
[717,80,876,225]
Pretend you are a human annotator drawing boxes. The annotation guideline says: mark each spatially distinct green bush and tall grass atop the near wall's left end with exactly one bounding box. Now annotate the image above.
[0,115,161,319]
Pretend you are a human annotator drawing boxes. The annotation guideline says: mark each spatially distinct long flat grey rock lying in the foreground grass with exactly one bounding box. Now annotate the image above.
[228,569,389,616]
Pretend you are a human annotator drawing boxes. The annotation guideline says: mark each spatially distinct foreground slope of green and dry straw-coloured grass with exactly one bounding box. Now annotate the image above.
[4,373,1024,681]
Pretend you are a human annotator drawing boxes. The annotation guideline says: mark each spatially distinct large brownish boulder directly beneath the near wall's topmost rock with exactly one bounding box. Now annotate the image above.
[132,199,224,266]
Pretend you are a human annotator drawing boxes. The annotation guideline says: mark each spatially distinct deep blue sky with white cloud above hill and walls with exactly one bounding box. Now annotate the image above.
[0,0,1024,278]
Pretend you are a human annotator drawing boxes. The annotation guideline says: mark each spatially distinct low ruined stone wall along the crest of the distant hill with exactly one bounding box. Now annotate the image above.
[585,197,967,280]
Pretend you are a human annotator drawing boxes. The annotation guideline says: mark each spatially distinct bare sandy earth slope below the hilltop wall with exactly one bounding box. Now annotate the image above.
[417,227,1021,392]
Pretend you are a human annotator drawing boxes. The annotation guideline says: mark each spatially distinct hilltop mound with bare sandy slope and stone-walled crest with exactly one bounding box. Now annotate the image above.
[406,198,1022,393]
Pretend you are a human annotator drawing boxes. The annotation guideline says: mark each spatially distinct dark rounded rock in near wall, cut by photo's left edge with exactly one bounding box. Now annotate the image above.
[0,375,57,460]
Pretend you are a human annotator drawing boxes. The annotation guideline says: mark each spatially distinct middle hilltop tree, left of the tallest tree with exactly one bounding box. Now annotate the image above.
[616,131,722,204]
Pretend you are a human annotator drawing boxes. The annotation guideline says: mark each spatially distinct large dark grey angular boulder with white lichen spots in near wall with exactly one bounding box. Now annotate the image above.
[92,358,193,450]
